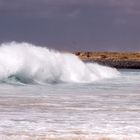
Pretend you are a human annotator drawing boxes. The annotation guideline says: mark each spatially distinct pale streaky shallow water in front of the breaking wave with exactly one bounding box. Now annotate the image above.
[0,70,140,140]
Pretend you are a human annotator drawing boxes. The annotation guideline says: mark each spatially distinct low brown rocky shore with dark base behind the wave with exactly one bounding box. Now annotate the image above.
[74,52,140,69]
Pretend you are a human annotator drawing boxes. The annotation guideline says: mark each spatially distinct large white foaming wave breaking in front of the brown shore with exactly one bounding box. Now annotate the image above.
[0,42,119,83]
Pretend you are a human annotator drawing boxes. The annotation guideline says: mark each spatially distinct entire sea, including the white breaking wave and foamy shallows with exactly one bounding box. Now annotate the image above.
[0,42,140,140]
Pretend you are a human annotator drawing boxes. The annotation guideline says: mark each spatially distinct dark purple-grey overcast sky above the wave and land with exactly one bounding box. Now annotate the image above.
[0,0,140,51]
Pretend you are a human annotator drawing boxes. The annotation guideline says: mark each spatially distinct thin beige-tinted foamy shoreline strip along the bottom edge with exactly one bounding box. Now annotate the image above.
[0,132,140,140]
